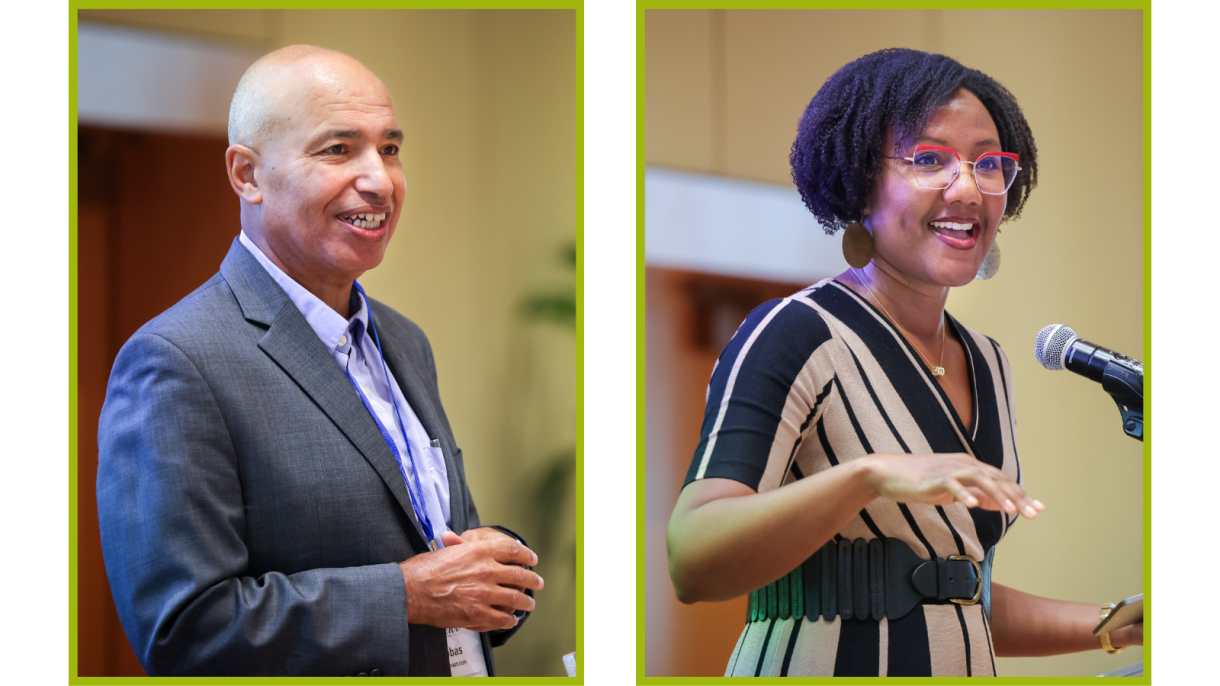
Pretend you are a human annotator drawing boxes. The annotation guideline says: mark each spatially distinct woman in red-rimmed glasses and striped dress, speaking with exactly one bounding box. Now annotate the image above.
[667,50,1143,676]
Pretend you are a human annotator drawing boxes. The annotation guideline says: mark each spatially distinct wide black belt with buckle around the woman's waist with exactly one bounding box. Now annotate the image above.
[747,538,996,621]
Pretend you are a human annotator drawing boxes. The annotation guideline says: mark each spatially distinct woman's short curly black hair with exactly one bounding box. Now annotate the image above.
[788,48,1038,234]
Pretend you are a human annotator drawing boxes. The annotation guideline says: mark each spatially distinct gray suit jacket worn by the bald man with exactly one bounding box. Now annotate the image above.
[98,239,525,676]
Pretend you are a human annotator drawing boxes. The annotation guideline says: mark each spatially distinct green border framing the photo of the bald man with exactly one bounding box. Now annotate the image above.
[68,0,584,684]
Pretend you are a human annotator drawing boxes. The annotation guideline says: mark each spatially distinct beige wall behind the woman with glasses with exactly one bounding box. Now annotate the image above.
[645,10,1143,675]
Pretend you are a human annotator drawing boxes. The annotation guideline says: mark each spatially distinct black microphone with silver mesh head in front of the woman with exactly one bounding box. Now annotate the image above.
[1033,323,1143,441]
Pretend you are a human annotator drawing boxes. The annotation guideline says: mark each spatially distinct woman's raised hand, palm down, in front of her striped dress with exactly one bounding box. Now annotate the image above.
[860,453,1044,519]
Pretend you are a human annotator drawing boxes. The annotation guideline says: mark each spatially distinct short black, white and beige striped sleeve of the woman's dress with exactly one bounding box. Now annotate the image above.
[682,298,831,491]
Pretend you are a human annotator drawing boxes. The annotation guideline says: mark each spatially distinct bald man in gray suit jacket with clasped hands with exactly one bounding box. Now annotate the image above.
[98,45,543,676]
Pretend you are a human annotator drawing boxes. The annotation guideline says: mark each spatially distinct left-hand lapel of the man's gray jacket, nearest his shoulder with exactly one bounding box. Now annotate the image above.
[221,239,428,549]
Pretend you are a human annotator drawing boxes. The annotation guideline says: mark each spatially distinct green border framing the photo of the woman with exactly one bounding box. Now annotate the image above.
[634,0,1153,684]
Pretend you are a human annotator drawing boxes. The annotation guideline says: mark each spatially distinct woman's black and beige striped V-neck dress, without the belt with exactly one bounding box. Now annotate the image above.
[683,280,1021,676]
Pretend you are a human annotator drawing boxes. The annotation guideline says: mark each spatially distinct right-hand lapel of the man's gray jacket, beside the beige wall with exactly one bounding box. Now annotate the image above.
[370,298,466,531]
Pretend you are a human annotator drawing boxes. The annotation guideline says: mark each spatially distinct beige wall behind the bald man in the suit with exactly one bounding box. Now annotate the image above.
[81,10,576,675]
